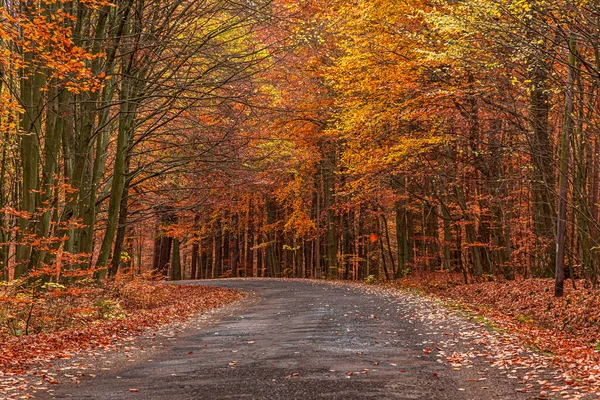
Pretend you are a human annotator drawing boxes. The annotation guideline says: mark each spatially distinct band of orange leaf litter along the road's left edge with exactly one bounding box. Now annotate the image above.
[0,280,243,399]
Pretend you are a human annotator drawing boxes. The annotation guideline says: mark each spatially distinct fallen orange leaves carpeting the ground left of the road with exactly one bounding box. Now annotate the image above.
[0,280,242,399]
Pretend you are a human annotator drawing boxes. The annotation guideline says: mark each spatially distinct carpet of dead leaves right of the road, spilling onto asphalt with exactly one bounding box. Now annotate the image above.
[365,274,600,399]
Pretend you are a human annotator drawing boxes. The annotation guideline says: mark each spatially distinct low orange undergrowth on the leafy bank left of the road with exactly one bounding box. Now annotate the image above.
[0,276,242,371]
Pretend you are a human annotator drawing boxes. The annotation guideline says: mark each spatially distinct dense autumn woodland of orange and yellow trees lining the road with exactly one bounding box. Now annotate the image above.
[0,0,600,296]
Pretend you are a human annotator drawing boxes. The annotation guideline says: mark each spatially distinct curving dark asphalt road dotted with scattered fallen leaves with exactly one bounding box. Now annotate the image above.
[36,279,533,400]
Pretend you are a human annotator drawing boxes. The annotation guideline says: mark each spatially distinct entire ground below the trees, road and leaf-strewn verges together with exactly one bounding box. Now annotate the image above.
[0,274,600,400]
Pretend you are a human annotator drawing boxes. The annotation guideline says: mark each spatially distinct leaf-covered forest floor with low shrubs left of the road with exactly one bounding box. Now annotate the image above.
[0,279,243,399]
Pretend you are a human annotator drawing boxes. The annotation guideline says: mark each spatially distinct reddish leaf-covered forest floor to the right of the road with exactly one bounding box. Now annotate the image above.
[384,273,600,397]
